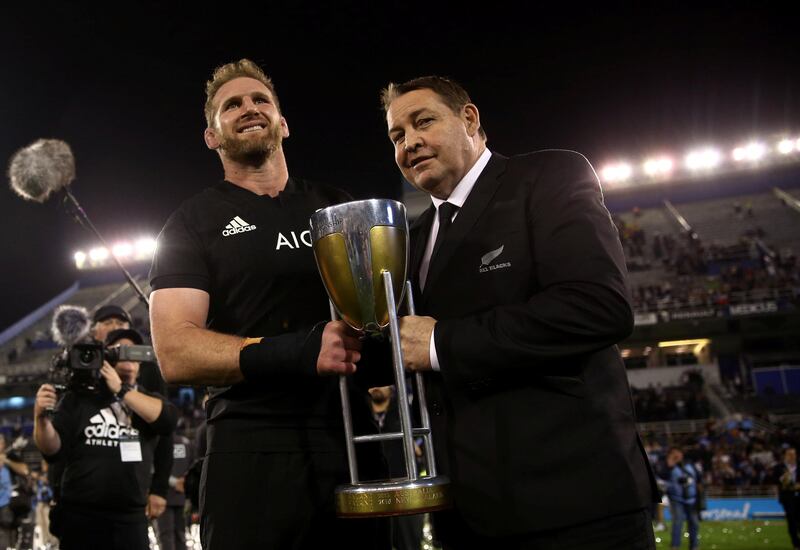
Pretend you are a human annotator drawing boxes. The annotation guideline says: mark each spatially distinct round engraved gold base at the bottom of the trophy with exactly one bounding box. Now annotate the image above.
[336,476,451,518]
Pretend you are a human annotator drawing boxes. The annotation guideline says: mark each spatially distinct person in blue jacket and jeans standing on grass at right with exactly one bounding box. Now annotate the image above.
[665,447,700,550]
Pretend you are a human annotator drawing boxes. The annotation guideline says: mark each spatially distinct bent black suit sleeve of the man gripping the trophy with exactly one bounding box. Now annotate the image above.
[434,152,633,384]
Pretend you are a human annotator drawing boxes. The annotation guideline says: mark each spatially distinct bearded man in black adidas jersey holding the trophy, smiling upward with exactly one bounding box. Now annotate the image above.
[150,59,389,550]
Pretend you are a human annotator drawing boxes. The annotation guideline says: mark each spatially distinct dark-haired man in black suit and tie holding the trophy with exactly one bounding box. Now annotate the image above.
[382,77,655,550]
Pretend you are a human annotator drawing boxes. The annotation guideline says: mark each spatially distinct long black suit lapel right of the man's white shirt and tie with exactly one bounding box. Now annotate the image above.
[422,153,508,303]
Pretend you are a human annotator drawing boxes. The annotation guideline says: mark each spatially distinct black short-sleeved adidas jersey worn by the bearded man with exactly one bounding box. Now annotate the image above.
[150,178,376,452]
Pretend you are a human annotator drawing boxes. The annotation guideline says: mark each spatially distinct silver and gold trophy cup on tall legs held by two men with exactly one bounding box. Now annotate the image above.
[311,199,450,517]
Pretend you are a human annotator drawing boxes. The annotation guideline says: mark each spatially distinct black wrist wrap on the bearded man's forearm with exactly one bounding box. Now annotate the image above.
[239,323,325,382]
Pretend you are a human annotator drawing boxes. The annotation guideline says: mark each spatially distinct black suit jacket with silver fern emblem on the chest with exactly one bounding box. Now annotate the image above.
[411,151,655,535]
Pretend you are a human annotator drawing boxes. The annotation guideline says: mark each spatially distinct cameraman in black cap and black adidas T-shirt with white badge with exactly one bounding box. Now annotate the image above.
[34,329,178,550]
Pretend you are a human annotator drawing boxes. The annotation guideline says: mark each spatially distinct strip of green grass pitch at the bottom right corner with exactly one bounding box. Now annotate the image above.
[656,520,792,550]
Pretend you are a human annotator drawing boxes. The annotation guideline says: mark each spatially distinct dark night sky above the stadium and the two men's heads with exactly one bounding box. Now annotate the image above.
[0,1,800,330]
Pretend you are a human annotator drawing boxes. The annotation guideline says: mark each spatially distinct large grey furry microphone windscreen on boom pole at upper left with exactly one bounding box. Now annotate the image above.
[8,139,75,202]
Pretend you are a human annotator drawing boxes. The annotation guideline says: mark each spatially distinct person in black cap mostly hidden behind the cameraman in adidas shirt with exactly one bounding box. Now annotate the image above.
[92,304,173,519]
